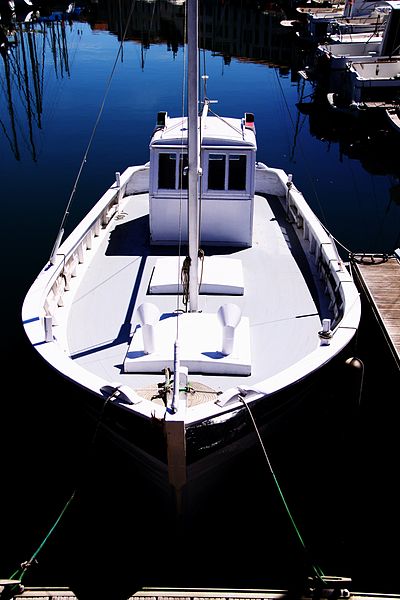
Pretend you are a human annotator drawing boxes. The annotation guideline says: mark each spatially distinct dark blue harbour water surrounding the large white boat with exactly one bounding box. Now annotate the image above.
[0,0,400,600]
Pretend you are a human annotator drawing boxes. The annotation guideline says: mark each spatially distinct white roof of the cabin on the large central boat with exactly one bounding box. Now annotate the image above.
[150,116,257,150]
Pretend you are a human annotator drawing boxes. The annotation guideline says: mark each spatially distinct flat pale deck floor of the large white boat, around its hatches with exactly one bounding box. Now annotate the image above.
[67,194,321,390]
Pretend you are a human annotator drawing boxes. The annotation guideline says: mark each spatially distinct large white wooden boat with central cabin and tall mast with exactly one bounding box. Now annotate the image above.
[22,0,361,506]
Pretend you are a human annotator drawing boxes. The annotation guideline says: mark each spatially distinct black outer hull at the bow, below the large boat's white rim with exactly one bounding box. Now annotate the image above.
[69,340,362,516]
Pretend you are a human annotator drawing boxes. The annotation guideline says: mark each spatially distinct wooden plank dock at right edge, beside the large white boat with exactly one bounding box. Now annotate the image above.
[350,250,400,369]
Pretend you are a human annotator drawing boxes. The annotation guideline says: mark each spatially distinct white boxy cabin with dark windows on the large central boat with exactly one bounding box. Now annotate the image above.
[149,112,257,247]
